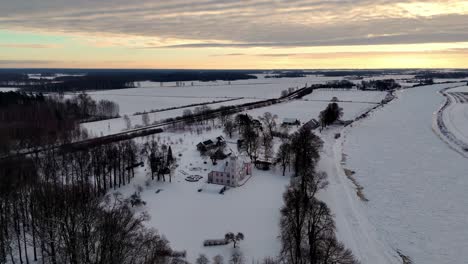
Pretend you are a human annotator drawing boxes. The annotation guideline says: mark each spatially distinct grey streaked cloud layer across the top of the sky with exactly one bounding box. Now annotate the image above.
[0,0,468,48]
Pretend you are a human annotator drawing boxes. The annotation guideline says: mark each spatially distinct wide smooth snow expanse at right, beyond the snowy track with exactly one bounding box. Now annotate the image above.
[337,84,468,263]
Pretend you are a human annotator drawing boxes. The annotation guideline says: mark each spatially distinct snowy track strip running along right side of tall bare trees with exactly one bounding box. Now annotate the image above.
[319,130,401,264]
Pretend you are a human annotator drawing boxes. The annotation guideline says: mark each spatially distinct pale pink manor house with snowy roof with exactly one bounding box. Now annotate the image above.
[208,156,252,187]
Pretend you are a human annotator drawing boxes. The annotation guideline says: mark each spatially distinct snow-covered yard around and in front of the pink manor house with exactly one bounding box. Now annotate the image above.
[114,129,289,263]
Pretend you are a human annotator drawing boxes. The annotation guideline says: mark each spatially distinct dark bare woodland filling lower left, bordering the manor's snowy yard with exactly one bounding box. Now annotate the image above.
[0,133,181,264]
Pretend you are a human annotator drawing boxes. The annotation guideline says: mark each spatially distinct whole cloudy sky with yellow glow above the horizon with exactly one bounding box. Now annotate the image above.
[0,0,468,69]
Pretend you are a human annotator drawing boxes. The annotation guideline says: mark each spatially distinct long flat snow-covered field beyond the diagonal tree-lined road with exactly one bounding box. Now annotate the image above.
[80,74,401,115]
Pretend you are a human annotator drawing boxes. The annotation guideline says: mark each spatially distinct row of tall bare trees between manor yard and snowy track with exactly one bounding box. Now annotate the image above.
[278,128,358,264]
